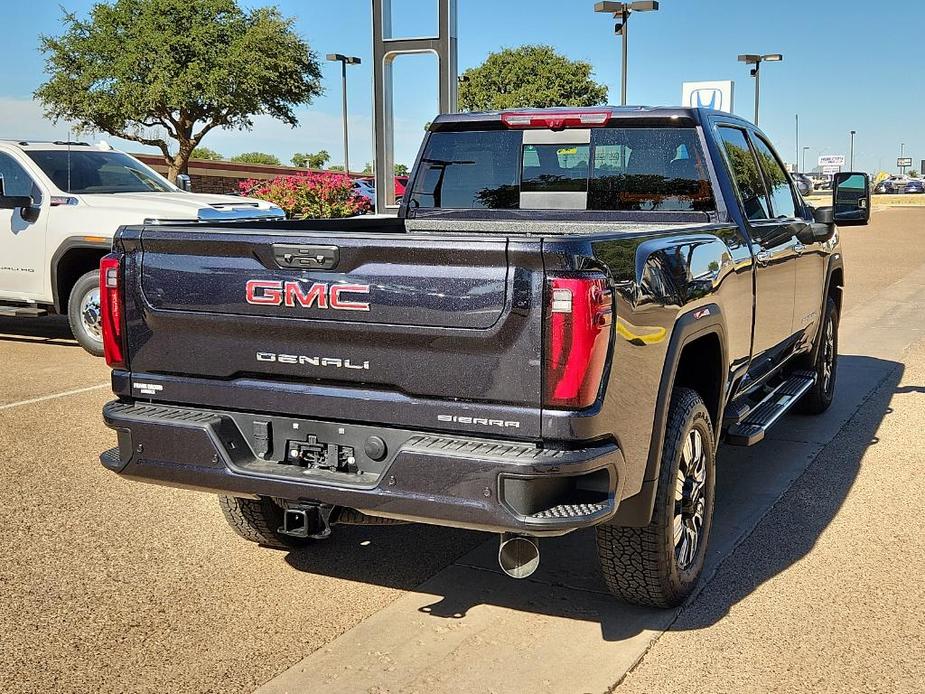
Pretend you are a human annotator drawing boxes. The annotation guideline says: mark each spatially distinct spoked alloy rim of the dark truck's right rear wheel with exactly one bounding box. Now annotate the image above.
[674,429,707,571]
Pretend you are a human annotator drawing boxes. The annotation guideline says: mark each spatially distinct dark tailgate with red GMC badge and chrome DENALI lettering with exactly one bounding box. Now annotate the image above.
[122,227,543,437]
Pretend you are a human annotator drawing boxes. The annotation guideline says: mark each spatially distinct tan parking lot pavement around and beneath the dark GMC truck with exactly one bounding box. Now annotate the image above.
[0,208,925,694]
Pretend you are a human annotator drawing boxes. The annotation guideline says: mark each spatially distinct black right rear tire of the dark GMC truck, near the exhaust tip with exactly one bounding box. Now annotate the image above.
[597,388,716,607]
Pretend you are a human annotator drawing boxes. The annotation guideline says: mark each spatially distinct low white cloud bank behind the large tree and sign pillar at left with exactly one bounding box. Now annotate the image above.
[0,97,424,169]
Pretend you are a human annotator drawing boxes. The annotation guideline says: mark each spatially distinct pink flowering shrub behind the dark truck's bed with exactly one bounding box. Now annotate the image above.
[238,171,372,219]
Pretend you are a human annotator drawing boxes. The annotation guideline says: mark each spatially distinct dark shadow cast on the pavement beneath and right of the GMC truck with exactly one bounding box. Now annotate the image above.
[287,355,904,641]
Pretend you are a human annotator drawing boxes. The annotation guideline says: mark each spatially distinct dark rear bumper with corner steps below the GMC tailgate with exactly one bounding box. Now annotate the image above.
[100,401,624,535]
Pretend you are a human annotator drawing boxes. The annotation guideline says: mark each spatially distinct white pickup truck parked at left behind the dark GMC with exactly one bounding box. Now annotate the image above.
[0,140,285,355]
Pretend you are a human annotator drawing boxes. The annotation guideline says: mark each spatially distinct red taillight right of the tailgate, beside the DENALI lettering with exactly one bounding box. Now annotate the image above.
[543,277,613,408]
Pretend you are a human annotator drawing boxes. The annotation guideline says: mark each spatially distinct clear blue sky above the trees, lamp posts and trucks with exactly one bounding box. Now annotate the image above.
[0,0,925,171]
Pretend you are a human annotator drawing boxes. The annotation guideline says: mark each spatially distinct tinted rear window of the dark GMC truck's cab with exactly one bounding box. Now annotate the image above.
[409,127,716,212]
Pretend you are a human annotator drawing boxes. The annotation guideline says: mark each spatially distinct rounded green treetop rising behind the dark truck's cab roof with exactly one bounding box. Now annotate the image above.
[459,45,607,111]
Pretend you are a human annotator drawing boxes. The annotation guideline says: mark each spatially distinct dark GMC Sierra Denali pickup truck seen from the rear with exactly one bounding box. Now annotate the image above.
[101,107,870,606]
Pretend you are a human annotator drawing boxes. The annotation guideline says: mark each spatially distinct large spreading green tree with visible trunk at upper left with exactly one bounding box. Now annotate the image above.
[35,0,323,180]
